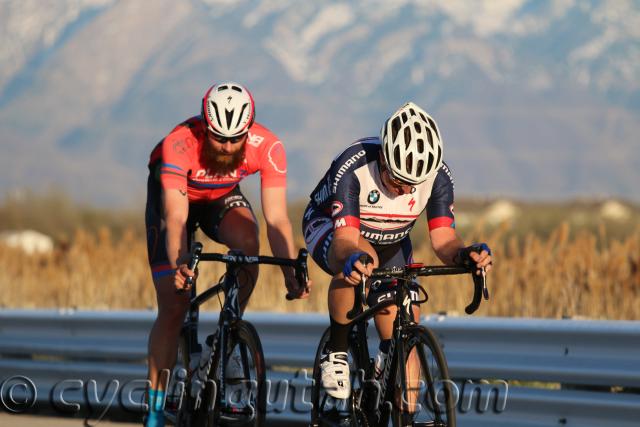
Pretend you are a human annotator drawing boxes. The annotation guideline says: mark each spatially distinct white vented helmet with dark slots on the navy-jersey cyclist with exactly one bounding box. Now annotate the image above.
[380,102,442,185]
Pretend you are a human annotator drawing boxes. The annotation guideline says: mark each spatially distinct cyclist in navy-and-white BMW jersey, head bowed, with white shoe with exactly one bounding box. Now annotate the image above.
[302,102,492,399]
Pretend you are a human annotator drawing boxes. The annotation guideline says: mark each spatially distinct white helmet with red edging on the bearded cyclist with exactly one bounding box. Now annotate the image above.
[202,82,255,138]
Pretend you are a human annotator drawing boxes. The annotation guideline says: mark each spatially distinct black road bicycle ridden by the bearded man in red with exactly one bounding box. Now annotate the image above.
[165,242,308,427]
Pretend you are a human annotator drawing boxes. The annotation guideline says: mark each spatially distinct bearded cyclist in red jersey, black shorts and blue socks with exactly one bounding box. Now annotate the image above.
[145,82,310,426]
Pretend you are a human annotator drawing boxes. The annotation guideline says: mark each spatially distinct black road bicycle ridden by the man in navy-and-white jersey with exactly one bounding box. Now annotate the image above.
[311,259,489,427]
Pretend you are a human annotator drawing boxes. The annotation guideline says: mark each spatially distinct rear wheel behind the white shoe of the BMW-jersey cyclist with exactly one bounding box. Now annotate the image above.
[311,328,369,427]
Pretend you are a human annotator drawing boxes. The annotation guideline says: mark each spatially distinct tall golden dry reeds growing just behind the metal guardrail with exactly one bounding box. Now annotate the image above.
[0,219,640,320]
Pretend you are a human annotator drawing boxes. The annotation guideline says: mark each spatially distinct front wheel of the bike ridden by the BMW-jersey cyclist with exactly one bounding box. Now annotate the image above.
[382,325,456,427]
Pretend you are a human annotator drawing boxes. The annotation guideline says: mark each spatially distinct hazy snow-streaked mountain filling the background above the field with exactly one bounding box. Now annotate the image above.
[0,0,640,203]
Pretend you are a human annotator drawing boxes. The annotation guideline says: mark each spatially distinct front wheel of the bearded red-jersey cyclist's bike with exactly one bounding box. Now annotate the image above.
[193,320,267,427]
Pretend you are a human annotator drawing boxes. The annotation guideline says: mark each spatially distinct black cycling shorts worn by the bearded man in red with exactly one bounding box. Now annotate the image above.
[145,175,255,279]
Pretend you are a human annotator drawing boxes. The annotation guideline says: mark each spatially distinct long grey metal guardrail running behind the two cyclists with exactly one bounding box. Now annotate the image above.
[0,310,640,427]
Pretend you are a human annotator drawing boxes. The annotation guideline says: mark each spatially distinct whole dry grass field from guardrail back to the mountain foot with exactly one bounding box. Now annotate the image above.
[0,195,640,320]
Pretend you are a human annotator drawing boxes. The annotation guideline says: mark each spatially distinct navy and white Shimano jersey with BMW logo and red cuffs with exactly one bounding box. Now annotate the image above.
[303,137,455,245]
